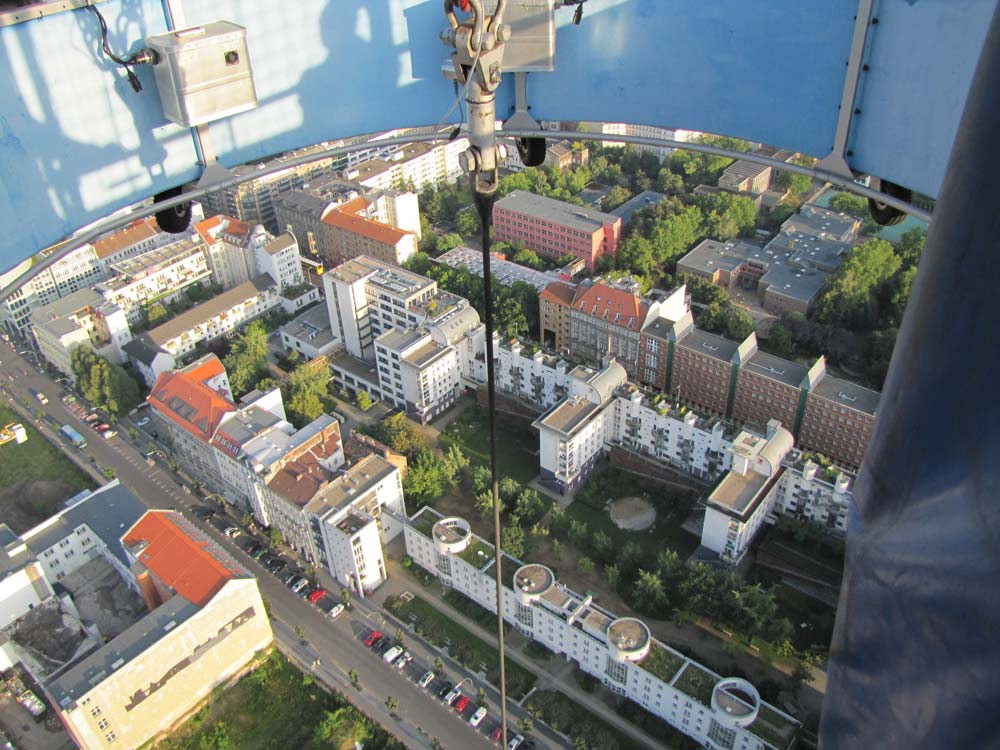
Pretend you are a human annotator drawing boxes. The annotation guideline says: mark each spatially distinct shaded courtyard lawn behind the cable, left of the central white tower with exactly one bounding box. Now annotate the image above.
[438,405,538,484]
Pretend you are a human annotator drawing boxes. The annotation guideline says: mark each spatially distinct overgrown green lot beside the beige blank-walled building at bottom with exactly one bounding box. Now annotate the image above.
[147,651,403,750]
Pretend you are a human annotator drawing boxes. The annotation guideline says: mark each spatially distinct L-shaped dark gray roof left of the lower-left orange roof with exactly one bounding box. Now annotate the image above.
[24,480,149,567]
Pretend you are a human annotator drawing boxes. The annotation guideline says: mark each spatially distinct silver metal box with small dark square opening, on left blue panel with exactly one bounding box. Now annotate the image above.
[146,21,257,127]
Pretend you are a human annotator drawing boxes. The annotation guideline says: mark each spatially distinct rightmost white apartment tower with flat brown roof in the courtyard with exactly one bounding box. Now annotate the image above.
[701,419,795,565]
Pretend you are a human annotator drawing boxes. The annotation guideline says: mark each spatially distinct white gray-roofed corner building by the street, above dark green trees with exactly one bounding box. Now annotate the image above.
[30,289,132,381]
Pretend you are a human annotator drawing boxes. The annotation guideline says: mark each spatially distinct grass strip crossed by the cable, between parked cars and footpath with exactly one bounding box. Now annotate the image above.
[386,596,535,700]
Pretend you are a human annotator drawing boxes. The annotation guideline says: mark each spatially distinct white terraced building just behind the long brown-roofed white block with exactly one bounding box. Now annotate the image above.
[95,235,212,325]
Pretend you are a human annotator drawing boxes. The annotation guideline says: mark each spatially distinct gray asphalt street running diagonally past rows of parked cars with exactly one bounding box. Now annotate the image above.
[0,342,556,750]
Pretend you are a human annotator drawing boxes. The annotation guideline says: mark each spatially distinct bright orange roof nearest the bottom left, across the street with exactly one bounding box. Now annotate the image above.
[122,510,246,607]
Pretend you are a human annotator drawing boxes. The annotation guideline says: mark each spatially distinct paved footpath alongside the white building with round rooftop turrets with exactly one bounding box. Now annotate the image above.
[369,558,670,750]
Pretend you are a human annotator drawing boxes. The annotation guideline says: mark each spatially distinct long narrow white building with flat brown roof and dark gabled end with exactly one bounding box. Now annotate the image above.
[124,274,281,386]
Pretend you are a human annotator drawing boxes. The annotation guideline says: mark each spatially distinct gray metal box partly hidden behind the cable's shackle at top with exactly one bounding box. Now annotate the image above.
[484,0,556,73]
